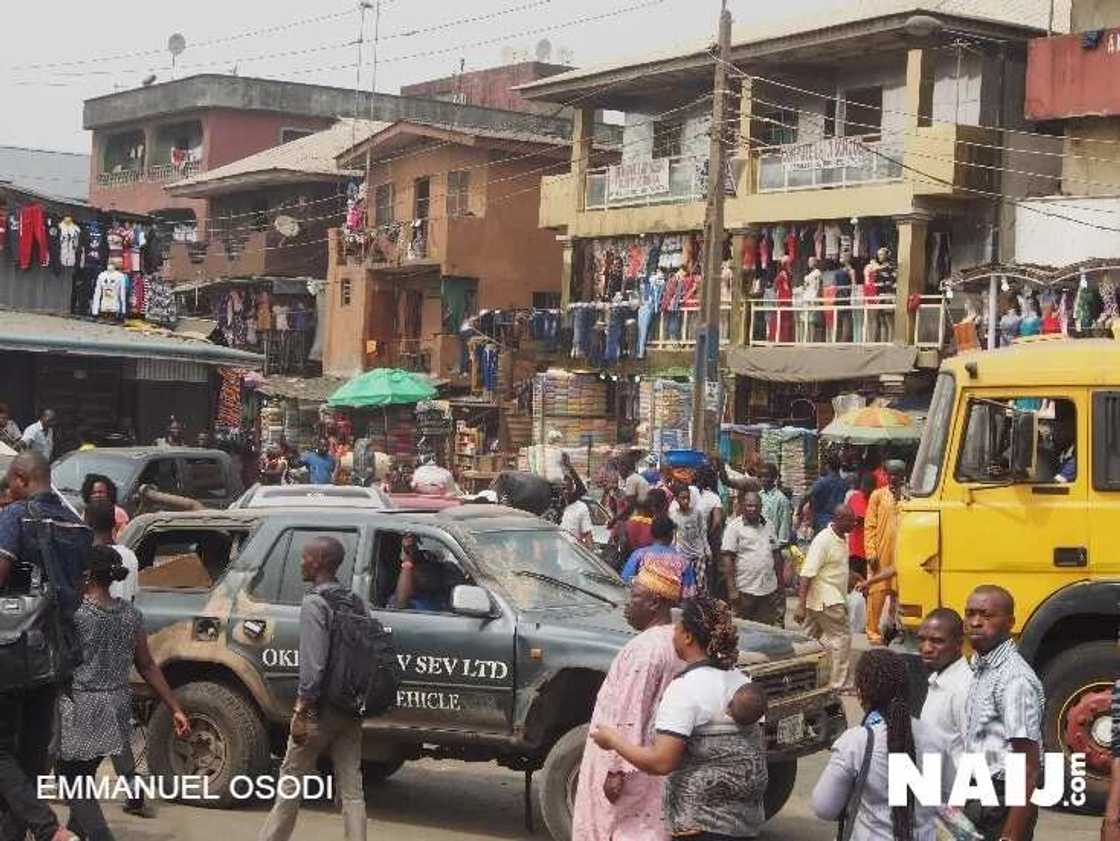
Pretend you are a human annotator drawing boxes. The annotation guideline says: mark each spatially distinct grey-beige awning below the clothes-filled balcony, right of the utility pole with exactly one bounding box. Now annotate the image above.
[727,345,917,383]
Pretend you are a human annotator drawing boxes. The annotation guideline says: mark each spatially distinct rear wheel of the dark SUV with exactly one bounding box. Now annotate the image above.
[148,681,269,809]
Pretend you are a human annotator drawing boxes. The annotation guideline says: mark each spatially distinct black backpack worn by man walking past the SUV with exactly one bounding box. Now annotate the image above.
[319,587,401,716]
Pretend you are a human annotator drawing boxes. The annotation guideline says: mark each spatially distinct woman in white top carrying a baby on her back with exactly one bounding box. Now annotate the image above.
[591,596,766,841]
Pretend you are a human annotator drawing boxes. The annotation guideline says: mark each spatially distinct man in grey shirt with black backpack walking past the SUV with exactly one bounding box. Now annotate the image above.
[259,538,400,841]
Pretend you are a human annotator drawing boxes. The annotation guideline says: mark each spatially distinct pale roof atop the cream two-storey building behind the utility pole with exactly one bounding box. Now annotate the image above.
[514,0,1071,93]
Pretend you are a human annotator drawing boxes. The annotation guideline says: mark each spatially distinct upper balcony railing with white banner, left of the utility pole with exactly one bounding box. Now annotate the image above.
[584,156,708,211]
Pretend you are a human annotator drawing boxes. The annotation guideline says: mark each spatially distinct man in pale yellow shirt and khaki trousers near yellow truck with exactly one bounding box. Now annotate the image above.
[793,505,856,690]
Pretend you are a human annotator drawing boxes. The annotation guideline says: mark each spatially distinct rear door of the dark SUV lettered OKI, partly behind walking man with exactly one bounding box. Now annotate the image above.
[228,521,361,710]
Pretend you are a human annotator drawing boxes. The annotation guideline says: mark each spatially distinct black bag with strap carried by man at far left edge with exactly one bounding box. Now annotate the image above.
[0,502,88,693]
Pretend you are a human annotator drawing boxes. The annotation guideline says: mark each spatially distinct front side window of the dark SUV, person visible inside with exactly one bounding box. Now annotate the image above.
[372,531,469,613]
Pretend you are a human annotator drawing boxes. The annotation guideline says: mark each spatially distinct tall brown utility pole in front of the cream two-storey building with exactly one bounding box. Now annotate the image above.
[692,0,731,452]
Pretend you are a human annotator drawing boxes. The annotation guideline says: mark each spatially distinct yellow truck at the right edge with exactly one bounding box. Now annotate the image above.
[896,337,1120,809]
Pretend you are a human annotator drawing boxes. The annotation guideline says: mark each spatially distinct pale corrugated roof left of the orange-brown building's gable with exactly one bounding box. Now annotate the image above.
[167,118,390,193]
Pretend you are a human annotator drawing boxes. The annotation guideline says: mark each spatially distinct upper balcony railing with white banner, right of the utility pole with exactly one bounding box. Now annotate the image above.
[755,134,903,193]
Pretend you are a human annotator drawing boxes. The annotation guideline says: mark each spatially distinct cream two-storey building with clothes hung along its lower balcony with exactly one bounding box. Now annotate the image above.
[520,0,1057,419]
